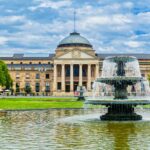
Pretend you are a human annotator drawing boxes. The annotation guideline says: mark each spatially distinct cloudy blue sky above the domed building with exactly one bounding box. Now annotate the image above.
[0,0,150,55]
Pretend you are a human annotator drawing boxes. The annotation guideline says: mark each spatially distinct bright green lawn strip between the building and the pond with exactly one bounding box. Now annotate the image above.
[0,97,83,110]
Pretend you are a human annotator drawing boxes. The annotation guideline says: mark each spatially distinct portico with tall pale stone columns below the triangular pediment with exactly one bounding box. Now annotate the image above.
[54,63,98,93]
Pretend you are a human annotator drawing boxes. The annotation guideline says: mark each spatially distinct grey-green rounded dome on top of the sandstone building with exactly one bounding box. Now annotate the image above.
[58,32,92,47]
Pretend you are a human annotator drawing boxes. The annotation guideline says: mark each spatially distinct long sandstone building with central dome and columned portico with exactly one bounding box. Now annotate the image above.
[0,32,150,96]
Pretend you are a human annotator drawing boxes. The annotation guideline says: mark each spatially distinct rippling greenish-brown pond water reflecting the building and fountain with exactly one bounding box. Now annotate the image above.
[0,109,150,150]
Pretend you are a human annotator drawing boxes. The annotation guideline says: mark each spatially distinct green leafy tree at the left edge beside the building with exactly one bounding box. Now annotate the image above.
[0,61,13,89]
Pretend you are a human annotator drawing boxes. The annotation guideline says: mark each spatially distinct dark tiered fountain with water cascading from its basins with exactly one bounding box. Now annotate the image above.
[85,56,150,121]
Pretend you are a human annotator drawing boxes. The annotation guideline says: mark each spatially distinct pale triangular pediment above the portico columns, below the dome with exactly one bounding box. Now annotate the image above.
[57,50,95,59]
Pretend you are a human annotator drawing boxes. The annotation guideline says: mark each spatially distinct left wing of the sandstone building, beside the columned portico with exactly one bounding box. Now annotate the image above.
[0,54,54,95]
